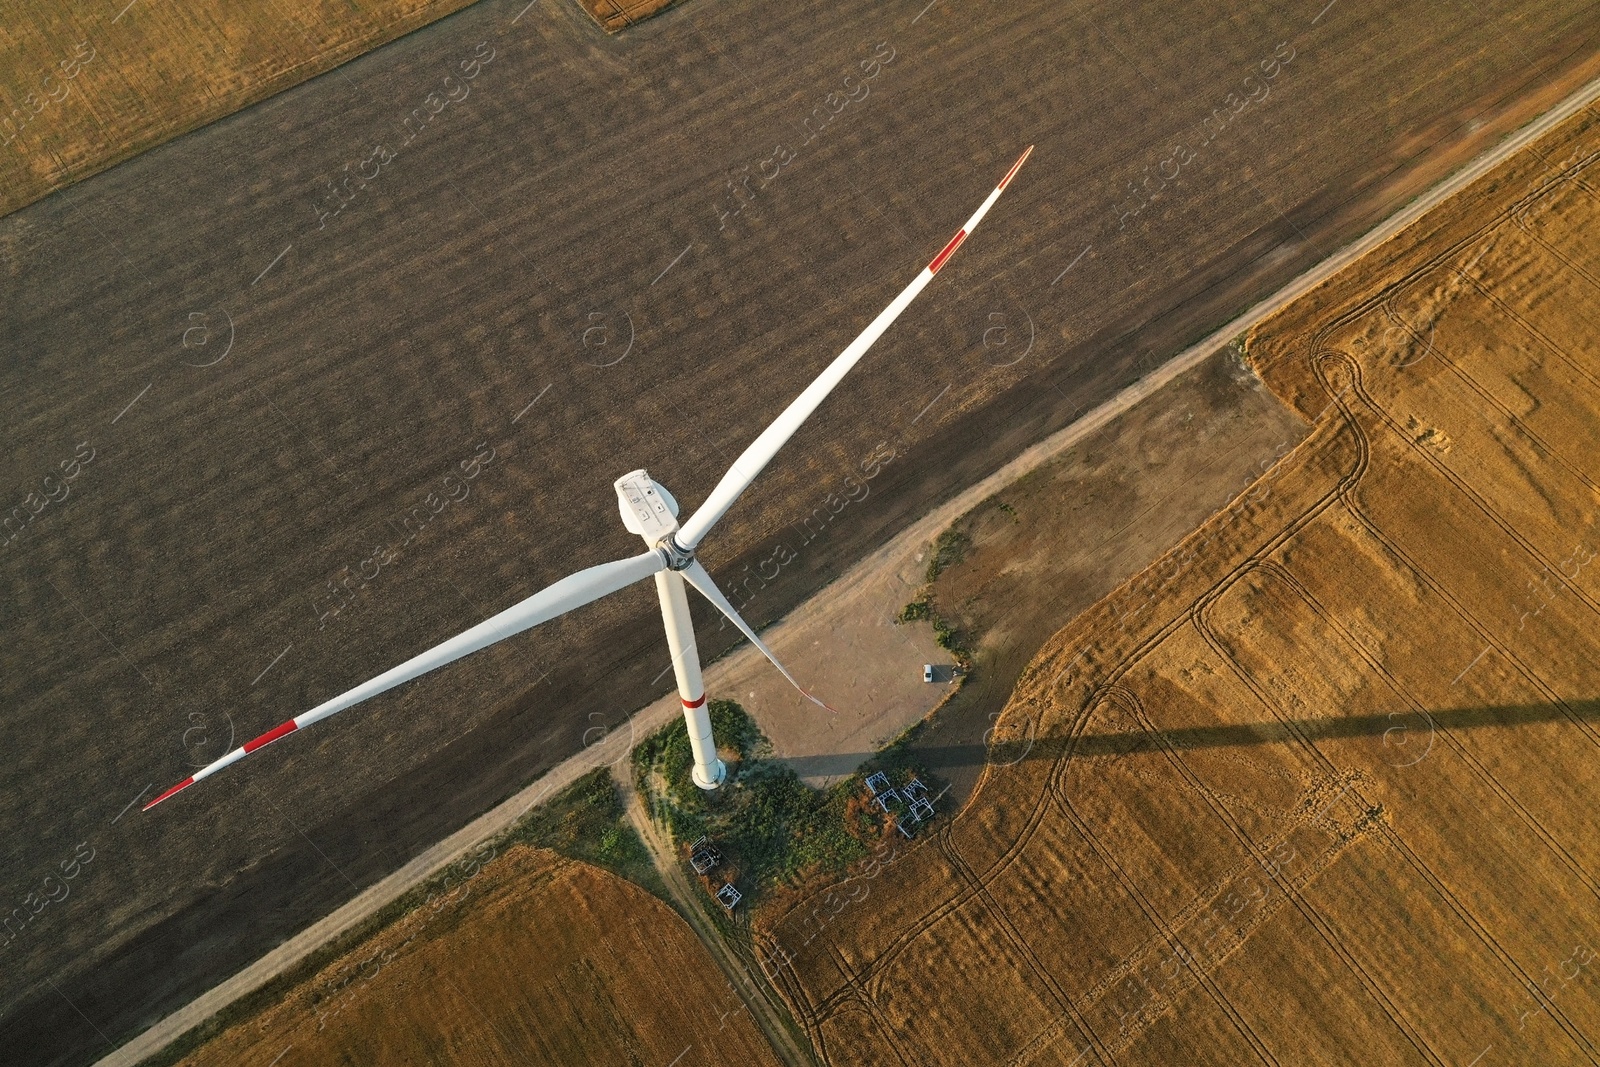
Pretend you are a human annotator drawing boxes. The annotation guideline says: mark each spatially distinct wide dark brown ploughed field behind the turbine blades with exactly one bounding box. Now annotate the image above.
[9,0,1600,1064]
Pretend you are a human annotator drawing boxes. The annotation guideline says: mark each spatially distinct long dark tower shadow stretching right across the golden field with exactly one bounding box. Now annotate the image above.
[776,699,1600,777]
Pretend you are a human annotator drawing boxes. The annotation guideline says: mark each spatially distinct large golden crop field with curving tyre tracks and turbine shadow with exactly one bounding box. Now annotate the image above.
[763,99,1600,1067]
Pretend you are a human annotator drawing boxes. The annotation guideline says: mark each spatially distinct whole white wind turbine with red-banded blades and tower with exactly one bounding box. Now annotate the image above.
[144,146,1034,811]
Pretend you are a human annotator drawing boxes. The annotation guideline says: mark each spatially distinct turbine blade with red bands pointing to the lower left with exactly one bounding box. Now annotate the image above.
[144,549,667,811]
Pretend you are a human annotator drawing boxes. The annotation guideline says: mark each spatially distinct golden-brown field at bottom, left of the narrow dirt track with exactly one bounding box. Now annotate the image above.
[168,846,778,1067]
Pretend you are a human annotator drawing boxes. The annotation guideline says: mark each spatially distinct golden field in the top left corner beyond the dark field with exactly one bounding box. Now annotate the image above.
[0,0,472,216]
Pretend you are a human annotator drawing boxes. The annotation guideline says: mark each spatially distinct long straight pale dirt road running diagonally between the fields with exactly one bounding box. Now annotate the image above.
[94,64,1600,1067]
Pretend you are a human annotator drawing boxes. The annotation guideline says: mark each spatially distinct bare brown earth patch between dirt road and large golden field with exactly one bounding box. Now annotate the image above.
[912,349,1306,808]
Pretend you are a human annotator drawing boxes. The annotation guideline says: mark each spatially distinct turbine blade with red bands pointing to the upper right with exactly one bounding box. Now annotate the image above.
[677,146,1034,549]
